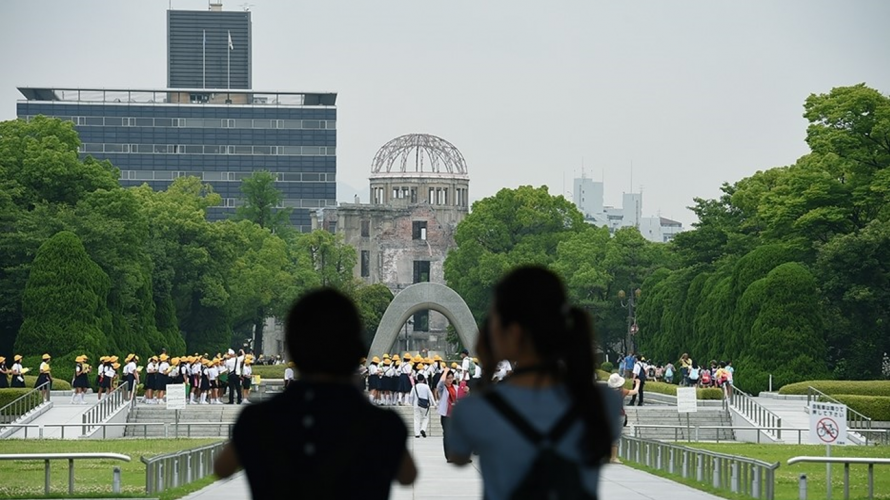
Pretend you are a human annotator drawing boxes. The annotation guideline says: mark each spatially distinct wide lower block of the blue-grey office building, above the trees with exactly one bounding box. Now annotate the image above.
[17,87,337,231]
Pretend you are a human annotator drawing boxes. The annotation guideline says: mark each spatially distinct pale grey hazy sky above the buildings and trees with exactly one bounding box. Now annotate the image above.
[0,0,890,225]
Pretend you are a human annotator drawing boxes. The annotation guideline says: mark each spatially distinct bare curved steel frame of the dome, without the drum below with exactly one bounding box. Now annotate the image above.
[371,134,467,175]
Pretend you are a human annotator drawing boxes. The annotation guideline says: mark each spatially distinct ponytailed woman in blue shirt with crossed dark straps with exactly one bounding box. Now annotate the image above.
[445,267,621,500]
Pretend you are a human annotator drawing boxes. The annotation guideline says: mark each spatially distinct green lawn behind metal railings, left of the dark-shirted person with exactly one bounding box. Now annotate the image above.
[0,439,219,499]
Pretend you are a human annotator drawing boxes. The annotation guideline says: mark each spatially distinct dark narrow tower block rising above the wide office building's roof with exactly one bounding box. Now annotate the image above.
[167,3,251,89]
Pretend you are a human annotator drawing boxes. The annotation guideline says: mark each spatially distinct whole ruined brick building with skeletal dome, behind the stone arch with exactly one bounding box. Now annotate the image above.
[312,134,470,351]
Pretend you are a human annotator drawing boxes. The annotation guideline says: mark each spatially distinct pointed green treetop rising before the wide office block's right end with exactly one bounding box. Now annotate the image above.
[235,170,293,233]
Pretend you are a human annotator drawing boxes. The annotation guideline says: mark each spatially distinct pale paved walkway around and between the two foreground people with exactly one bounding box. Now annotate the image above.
[184,438,721,500]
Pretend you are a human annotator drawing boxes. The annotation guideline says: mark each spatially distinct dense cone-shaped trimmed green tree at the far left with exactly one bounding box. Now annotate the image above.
[15,231,111,356]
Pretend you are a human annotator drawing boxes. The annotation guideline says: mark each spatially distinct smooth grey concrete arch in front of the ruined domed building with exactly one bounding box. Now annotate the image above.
[368,283,479,359]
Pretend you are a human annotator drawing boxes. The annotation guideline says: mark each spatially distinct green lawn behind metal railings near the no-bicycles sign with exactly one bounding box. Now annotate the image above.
[626,443,890,500]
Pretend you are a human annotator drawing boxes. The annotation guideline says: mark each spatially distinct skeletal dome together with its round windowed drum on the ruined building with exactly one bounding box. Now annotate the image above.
[370,134,470,212]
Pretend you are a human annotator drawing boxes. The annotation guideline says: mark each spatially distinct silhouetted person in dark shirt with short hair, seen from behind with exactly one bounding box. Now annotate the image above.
[214,289,417,500]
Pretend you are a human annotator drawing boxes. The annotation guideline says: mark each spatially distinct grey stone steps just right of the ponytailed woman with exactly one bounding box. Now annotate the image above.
[624,406,735,441]
